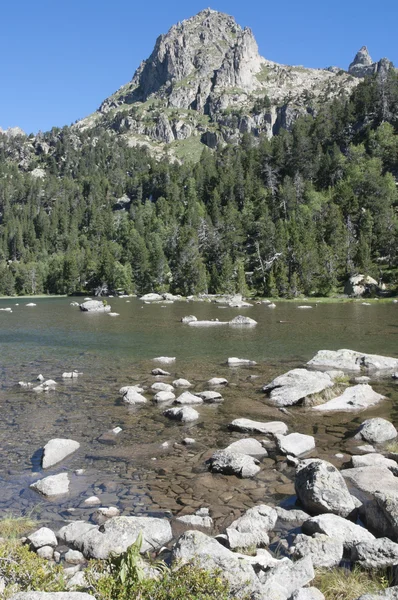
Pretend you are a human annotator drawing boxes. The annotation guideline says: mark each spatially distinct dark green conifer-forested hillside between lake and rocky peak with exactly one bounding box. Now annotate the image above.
[0,69,398,297]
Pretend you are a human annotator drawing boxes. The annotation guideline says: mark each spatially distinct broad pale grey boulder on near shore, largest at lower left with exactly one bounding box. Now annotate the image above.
[79,517,173,560]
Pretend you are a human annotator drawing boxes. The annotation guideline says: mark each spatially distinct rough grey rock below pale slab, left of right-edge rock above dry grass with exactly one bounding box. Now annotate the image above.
[289,533,344,568]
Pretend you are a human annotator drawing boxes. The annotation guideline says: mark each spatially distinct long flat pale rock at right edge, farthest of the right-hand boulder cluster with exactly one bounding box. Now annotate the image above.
[307,349,398,371]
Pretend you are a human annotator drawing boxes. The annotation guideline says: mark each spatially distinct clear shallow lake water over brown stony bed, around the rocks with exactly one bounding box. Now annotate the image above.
[0,298,398,527]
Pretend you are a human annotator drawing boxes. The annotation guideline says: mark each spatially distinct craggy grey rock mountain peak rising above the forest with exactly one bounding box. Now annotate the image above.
[75,9,390,158]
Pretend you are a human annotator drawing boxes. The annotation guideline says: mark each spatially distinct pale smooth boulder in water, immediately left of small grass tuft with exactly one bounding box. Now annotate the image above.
[263,369,334,406]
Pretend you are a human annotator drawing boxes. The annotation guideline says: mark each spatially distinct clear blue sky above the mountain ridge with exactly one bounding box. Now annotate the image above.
[0,0,398,133]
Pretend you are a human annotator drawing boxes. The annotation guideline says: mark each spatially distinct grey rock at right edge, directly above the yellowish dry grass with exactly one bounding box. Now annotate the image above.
[351,538,398,569]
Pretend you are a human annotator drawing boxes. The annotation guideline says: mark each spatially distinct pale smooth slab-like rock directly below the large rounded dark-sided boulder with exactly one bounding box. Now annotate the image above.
[302,514,375,549]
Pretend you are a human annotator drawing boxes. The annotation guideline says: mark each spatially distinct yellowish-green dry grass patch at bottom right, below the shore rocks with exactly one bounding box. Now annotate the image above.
[312,567,389,600]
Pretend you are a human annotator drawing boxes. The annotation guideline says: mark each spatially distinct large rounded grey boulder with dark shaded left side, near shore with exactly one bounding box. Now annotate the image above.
[295,459,355,517]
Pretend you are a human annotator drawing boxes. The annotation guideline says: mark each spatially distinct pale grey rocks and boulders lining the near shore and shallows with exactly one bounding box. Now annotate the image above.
[3,350,398,600]
